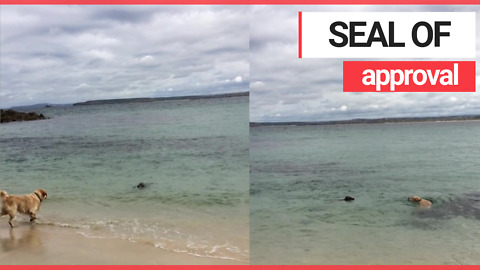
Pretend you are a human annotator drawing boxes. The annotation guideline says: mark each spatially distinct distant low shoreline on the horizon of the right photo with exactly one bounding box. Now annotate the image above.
[250,115,480,127]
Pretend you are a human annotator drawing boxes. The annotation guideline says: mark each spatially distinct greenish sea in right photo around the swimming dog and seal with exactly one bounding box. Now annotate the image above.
[250,121,480,264]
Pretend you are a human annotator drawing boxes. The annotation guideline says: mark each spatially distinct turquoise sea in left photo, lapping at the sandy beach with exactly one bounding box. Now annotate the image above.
[0,97,249,263]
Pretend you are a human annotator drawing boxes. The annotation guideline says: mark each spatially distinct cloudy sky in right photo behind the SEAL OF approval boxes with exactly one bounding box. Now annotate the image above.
[250,6,480,122]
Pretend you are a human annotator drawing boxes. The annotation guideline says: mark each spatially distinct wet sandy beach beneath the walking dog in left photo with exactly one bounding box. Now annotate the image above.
[0,220,247,265]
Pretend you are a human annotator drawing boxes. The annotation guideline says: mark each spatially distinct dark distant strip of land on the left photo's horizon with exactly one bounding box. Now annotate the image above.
[73,92,250,106]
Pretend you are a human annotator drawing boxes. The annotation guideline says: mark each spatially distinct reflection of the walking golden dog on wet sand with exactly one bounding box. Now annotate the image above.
[0,225,43,252]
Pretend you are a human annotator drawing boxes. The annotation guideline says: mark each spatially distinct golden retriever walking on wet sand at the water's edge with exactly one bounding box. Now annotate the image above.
[0,189,47,228]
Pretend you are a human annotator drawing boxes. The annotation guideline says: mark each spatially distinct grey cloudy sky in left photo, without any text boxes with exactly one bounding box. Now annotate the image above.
[0,6,250,108]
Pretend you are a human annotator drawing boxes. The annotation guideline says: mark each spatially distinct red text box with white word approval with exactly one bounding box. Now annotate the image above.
[343,61,475,92]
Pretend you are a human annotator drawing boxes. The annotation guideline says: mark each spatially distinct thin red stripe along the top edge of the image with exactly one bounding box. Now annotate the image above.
[1,0,480,5]
